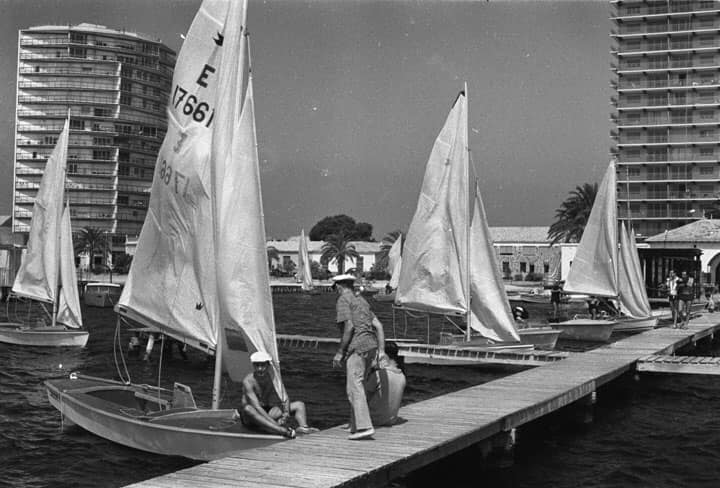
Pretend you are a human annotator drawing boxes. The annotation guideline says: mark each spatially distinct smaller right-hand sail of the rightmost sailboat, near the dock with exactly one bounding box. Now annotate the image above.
[618,223,652,318]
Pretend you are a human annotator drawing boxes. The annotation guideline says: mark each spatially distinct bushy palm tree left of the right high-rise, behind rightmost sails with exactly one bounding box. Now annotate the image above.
[548,183,597,245]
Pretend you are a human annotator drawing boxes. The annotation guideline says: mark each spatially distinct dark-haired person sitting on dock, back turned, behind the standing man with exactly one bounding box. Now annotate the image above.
[365,342,407,426]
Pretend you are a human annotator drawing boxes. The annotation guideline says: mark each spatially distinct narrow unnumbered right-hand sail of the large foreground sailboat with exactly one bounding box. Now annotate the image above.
[211,2,286,398]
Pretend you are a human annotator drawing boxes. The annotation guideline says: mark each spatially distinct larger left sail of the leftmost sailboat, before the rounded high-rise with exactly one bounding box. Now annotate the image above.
[12,120,70,303]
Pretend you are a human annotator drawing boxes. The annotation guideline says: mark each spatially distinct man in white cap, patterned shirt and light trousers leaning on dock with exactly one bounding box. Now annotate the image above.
[333,274,386,440]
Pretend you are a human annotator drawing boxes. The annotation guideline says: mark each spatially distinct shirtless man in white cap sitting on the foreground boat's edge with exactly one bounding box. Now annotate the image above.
[240,351,317,439]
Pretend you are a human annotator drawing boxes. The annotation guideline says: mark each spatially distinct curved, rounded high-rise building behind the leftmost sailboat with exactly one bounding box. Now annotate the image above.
[13,24,175,248]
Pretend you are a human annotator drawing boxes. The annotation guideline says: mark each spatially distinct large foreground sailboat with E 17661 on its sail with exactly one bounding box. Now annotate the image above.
[45,0,286,460]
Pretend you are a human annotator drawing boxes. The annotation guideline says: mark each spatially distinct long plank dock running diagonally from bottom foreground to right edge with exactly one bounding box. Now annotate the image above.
[126,315,720,488]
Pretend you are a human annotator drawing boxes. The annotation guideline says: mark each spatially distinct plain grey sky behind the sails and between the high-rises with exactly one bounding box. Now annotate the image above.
[0,0,612,240]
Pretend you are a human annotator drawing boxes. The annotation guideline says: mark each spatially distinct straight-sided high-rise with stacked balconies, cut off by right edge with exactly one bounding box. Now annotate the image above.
[611,0,720,237]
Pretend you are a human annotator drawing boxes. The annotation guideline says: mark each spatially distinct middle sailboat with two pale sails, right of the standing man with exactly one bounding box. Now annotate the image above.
[395,89,560,360]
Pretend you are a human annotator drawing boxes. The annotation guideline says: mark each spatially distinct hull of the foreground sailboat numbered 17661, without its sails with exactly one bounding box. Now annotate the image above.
[45,377,285,461]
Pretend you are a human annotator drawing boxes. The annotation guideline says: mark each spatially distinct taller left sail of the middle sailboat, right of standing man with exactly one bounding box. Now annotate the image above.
[395,93,469,315]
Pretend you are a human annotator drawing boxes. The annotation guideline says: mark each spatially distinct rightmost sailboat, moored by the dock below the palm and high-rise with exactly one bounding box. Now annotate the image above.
[553,160,657,342]
